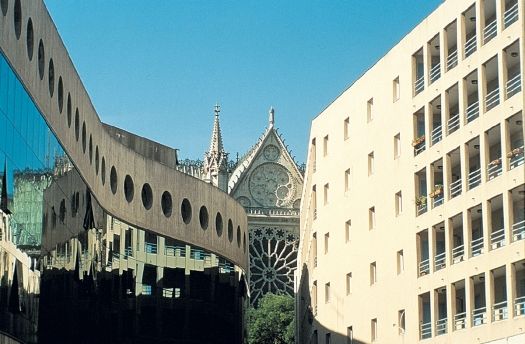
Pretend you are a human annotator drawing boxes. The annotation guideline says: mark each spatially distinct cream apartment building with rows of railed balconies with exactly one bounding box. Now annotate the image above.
[296,0,525,344]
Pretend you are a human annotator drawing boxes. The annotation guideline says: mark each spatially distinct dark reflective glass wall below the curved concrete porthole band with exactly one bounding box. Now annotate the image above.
[0,49,247,344]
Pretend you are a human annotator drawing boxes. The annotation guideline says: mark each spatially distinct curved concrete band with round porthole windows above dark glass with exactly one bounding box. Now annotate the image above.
[0,0,248,271]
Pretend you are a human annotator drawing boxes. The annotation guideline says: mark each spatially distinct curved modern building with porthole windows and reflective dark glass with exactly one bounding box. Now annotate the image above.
[0,0,248,343]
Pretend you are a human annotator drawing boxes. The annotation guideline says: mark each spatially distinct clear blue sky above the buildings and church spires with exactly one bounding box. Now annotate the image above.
[45,0,442,162]
